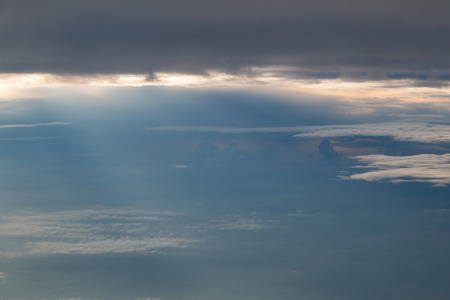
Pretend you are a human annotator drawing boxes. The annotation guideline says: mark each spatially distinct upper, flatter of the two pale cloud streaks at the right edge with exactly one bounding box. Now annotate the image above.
[294,123,450,144]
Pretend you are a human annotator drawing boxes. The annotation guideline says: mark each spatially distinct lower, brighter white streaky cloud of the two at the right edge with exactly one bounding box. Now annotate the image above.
[341,154,450,186]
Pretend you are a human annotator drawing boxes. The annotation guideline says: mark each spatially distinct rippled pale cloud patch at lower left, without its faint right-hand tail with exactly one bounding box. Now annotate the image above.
[0,209,196,257]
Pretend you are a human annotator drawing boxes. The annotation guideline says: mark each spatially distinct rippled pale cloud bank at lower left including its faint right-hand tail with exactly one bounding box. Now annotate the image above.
[0,209,274,256]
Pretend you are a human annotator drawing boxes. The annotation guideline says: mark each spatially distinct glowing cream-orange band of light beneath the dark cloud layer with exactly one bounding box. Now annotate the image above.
[0,69,450,106]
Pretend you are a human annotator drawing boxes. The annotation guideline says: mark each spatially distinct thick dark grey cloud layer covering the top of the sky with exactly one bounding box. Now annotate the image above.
[0,1,450,77]
